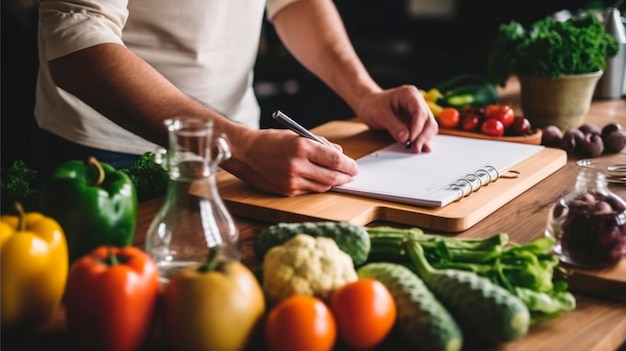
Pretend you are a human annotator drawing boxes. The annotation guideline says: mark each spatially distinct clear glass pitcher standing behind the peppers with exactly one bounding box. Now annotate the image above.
[145,118,241,282]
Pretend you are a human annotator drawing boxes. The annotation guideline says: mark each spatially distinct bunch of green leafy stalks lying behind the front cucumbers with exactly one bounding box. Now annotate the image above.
[367,227,576,320]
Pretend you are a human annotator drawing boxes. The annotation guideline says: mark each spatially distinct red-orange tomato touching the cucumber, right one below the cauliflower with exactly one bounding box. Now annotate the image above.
[330,278,396,350]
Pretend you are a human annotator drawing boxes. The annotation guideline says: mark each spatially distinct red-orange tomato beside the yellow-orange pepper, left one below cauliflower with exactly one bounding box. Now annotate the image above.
[263,295,337,351]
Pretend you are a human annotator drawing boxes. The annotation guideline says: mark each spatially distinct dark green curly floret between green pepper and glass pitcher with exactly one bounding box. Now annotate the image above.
[120,152,169,202]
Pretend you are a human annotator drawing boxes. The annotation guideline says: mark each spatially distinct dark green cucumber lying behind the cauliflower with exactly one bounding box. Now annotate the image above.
[252,221,371,266]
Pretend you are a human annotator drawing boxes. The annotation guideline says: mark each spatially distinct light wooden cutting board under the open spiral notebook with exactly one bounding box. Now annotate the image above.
[217,120,567,232]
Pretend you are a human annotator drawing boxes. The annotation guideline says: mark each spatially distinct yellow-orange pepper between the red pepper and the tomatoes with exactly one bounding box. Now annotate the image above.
[162,246,265,351]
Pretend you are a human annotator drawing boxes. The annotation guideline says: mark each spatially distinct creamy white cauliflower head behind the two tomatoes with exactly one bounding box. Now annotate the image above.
[263,234,358,303]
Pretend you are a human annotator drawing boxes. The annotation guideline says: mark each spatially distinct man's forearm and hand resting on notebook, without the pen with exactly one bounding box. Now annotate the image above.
[272,0,438,152]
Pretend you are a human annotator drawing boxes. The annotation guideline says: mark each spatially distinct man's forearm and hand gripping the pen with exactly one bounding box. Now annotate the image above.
[49,44,356,196]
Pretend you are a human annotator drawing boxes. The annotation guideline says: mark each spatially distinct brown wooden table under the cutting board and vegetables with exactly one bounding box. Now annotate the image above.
[2,81,626,351]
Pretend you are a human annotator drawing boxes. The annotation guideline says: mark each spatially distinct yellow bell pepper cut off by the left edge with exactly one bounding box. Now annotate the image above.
[0,205,69,330]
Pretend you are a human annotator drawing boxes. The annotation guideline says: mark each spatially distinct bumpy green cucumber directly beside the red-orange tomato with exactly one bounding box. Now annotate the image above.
[357,262,463,351]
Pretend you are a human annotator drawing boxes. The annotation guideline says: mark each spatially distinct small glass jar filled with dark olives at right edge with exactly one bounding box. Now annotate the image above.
[546,168,626,268]
